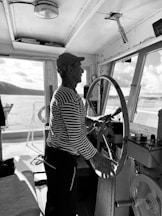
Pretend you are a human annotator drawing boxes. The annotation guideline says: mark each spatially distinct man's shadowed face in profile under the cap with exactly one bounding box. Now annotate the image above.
[71,62,84,83]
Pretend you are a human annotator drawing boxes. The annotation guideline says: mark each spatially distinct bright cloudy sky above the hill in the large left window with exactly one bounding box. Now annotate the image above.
[0,58,44,90]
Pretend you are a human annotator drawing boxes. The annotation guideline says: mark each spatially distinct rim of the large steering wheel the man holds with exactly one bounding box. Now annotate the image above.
[85,76,129,175]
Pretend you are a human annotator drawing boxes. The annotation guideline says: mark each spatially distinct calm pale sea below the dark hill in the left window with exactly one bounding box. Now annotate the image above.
[1,95,45,131]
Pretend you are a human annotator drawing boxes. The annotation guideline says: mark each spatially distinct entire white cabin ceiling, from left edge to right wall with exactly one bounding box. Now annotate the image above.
[0,0,162,54]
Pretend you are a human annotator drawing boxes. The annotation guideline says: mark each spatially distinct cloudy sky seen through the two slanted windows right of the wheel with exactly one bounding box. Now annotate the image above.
[111,51,162,95]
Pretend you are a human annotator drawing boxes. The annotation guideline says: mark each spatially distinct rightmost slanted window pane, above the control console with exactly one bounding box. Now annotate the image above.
[134,51,162,128]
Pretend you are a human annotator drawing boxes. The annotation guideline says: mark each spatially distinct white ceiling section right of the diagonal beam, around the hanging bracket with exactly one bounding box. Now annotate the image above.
[68,0,162,54]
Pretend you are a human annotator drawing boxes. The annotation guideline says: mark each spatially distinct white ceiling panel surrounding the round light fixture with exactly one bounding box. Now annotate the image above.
[10,0,86,44]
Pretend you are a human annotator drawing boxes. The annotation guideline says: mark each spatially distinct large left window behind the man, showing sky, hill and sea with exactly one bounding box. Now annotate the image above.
[0,58,44,133]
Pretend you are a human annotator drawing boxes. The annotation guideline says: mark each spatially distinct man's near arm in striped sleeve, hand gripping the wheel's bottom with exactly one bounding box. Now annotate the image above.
[62,104,114,178]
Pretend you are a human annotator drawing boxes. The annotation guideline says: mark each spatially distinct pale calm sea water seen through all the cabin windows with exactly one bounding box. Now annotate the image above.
[1,95,162,131]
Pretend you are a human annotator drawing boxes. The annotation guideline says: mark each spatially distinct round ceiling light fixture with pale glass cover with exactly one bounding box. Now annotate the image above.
[34,0,59,19]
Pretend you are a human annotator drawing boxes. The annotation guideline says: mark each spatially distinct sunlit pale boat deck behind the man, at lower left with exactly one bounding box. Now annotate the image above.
[2,138,47,215]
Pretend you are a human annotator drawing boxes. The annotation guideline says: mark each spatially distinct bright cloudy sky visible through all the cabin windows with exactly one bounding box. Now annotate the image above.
[0,51,162,94]
